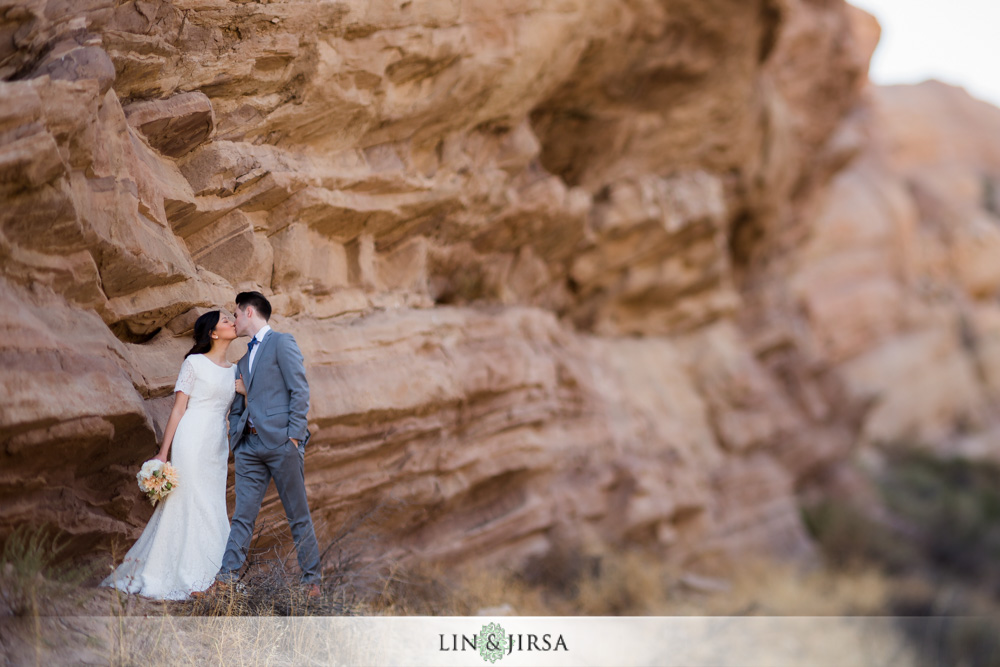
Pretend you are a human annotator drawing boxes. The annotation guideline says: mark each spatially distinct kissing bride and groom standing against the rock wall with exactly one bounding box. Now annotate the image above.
[101,292,320,600]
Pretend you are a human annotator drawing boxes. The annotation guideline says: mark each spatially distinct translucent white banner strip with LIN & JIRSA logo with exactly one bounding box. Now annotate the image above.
[31,616,933,667]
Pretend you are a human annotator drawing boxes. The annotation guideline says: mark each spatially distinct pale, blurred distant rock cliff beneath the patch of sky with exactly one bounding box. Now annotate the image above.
[790,82,1000,456]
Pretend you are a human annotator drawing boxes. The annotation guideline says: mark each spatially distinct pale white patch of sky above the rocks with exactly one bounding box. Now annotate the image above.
[850,0,1000,106]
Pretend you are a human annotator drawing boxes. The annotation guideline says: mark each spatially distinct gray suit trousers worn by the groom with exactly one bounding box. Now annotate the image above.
[216,433,320,584]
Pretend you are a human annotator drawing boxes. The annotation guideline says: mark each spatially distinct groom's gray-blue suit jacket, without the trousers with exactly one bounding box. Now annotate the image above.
[229,329,309,449]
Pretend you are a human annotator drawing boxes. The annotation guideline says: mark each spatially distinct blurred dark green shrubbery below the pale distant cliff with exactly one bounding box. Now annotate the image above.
[804,454,1000,666]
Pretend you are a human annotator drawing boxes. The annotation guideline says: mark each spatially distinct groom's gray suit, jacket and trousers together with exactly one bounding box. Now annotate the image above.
[216,330,320,583]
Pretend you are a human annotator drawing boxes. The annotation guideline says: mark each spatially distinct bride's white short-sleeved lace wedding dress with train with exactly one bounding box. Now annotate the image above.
[101,354,236,600]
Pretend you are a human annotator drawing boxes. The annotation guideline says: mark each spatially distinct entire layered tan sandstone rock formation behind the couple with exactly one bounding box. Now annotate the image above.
[0,0,1000,572]
